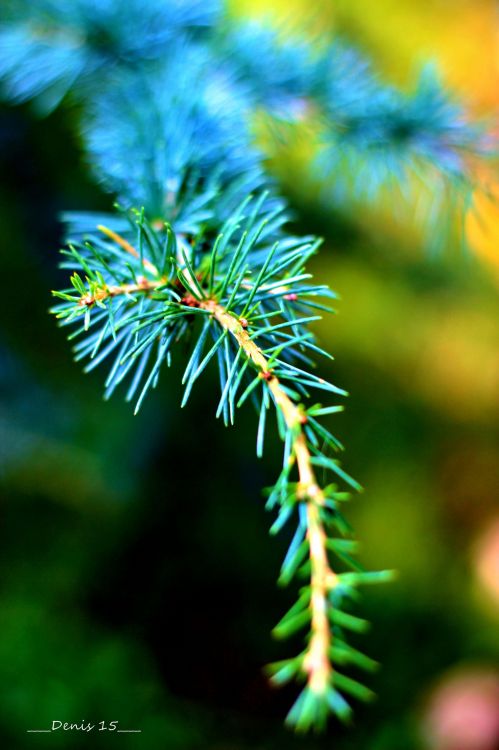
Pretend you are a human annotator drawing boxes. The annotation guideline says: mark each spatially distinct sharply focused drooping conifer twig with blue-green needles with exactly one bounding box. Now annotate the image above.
[48,204,396,730]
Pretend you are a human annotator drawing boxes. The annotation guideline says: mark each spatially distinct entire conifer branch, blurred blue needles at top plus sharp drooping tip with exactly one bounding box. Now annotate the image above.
[0,0,488,730]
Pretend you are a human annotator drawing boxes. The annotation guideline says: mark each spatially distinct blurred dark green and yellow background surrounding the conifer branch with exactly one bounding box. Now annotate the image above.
[0,0,499,750]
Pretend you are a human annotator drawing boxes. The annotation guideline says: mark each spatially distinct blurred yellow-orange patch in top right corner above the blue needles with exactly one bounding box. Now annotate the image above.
[230,0,499,108]
